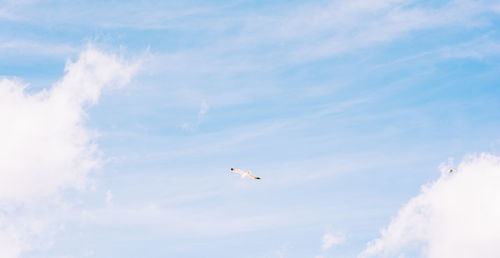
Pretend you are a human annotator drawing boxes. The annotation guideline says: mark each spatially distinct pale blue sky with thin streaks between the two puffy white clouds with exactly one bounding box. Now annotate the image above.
[0,1,500,257]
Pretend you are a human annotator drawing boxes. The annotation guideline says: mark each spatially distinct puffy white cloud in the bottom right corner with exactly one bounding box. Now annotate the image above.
[360,154,500,258]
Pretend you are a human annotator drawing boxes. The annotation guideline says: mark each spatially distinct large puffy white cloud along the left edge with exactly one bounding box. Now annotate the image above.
[0,48,137,257]
